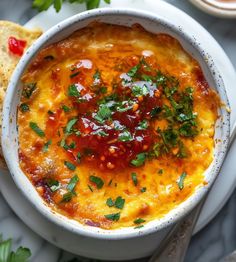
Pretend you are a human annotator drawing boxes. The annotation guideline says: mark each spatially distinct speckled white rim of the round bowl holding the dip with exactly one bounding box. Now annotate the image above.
[2,8,230,240]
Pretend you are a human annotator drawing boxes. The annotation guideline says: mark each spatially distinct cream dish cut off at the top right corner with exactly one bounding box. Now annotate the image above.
[190,0,236,18]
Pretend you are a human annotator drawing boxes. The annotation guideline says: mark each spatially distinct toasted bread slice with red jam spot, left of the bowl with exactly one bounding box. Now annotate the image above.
[0,21,42,168]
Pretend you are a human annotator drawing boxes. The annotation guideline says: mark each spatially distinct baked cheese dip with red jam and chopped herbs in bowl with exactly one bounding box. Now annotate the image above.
[18,22,220,229]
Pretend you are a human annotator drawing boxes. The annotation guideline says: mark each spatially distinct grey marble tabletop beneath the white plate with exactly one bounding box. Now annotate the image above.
[0,0,236,262]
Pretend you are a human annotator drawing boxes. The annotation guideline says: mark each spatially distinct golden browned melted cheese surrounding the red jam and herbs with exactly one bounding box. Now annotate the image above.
[18,24,219,229]
